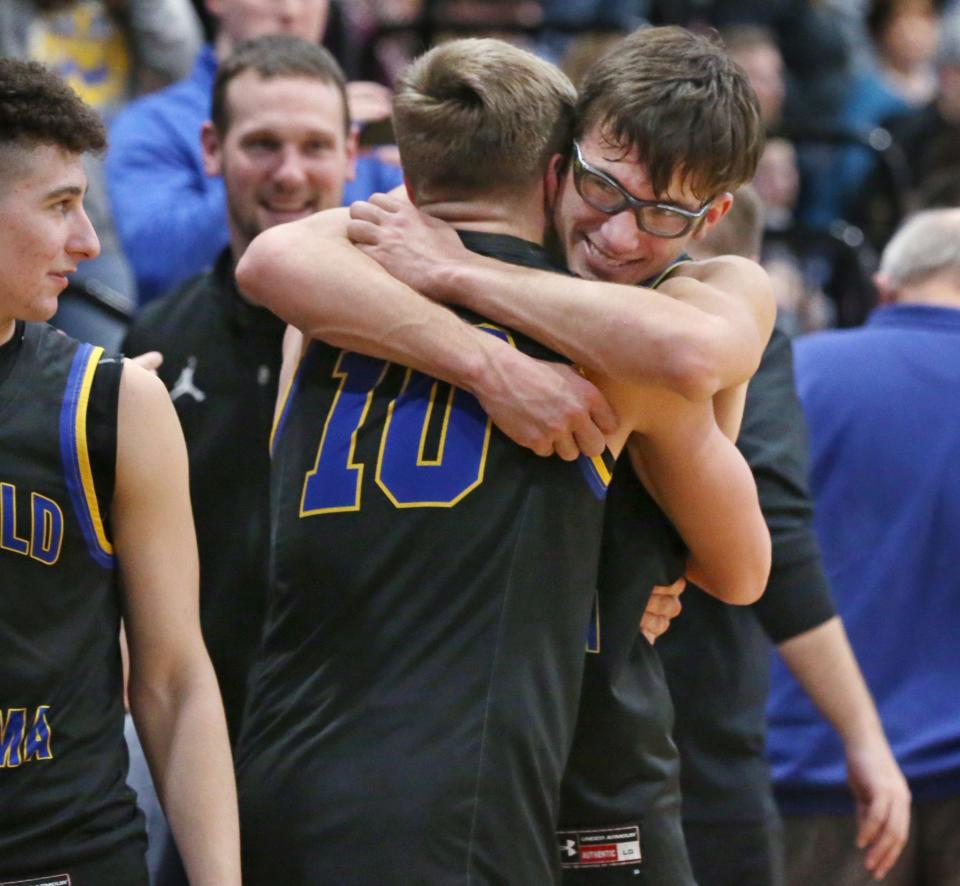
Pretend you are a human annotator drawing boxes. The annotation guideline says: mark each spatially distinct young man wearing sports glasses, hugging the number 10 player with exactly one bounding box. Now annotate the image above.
[310,28,774,886]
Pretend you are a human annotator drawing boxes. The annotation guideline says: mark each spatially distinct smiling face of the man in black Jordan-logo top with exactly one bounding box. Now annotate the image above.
[203,71,356,258]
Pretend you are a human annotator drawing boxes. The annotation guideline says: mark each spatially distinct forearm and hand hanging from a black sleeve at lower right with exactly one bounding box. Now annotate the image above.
[778,616,910,879]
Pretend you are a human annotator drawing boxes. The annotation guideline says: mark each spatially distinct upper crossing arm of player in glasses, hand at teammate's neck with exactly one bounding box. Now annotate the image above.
[348,195,775,399]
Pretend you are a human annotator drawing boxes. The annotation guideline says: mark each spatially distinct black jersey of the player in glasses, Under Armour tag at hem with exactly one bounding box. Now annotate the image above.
[558,266,692,886]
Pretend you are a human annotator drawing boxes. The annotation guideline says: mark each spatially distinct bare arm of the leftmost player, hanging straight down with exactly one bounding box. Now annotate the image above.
[112,361,240,886]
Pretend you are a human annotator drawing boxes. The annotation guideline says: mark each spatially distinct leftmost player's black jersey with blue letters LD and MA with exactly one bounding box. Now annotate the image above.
[0,324,146,886]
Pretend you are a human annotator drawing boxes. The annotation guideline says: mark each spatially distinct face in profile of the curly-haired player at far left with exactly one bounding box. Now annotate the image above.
[0,145,100,342]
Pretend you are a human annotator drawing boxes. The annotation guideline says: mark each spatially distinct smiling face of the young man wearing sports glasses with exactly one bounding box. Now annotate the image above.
[553,128,730,284]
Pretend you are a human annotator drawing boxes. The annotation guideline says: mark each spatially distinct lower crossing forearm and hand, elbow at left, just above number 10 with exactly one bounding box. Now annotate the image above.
[237,210,617,458]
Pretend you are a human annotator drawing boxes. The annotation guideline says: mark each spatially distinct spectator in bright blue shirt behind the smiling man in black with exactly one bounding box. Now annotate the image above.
[106,0,401,305]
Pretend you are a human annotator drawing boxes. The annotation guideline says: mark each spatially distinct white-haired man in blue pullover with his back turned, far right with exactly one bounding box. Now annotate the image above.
[768,209,960,886]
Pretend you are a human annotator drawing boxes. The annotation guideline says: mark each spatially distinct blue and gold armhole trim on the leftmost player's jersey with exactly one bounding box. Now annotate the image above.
[60,344,114,569]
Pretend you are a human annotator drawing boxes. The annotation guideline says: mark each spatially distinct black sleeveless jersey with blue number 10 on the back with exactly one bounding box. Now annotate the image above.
[238,234,612,886]
